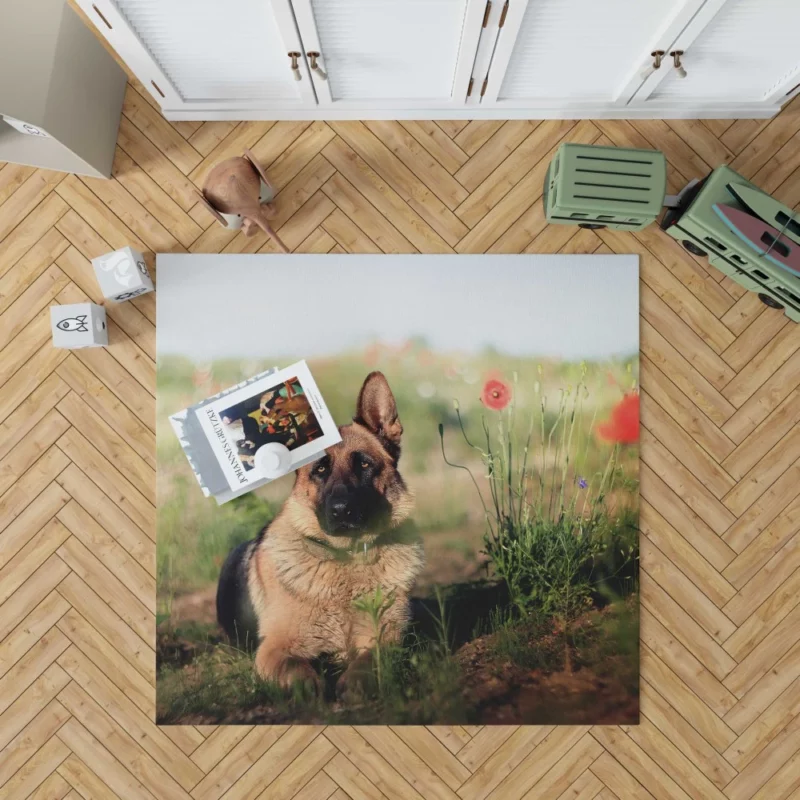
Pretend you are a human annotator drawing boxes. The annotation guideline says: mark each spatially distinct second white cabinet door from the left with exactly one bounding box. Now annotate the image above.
[292,0,487,108]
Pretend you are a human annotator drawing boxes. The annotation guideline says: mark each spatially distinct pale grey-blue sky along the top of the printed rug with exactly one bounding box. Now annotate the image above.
[156,254,639,362]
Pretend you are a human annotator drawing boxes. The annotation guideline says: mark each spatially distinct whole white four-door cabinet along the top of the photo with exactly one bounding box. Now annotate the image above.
[76,0,800,119]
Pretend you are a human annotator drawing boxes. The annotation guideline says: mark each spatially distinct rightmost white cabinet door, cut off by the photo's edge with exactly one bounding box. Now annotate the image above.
[634,0,800,111]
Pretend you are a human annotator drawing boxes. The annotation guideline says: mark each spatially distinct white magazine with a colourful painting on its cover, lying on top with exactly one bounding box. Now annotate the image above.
[194,361,341,491]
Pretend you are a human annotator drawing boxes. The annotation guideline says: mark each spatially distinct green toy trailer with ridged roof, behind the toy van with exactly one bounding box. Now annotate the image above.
[543,144,667,231]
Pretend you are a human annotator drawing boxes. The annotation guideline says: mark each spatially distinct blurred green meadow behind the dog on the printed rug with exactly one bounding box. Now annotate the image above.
[157,339,638,624]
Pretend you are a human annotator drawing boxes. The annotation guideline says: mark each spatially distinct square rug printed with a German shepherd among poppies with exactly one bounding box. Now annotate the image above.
[157,254,639,725]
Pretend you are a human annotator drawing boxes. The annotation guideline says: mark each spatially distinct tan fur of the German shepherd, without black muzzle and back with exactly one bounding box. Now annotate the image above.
[242,372,423,686]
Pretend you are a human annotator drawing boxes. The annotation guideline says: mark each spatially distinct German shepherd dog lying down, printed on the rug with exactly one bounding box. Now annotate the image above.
[217,372,424,694]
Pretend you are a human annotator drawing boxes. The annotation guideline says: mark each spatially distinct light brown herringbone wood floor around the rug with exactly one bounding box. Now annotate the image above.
[0,70,800,800]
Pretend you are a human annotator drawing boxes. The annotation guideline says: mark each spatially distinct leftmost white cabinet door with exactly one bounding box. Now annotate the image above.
[78,0,316,111]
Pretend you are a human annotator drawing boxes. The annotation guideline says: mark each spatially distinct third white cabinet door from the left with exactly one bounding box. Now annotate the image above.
[481,0,703,110]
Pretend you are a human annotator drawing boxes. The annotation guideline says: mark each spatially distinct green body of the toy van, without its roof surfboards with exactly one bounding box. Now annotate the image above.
[661,166,800,322]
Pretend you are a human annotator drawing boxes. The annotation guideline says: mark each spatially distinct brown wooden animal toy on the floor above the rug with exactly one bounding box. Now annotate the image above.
[200,150,289,253]
